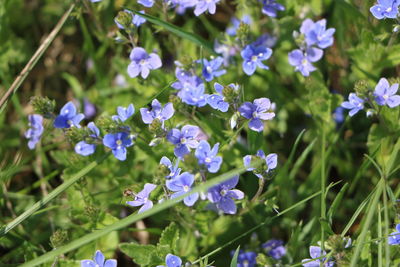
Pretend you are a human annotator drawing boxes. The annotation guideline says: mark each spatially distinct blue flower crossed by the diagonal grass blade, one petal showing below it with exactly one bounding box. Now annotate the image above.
[166,172,199,207]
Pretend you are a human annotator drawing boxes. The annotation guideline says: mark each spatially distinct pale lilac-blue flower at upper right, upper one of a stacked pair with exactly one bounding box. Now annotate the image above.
[300,19,335,49]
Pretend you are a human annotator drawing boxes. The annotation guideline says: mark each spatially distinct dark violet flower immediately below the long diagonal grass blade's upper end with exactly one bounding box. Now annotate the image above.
[207,175,244,214]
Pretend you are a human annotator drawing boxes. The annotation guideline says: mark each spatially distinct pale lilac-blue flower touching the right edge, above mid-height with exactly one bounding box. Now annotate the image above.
[374,78,400,108]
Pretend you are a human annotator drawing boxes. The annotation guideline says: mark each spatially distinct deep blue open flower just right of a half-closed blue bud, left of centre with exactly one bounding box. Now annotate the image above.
[103,132,133,161]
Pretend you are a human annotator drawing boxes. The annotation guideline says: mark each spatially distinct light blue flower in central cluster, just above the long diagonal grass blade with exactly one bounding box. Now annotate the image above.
[195,140,222,173]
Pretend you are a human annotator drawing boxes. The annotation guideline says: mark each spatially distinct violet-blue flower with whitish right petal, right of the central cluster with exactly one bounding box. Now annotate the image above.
[238,97,275,132]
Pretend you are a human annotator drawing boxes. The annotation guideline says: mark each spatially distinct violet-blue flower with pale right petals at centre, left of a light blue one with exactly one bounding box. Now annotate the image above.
[167,125,199,158]
